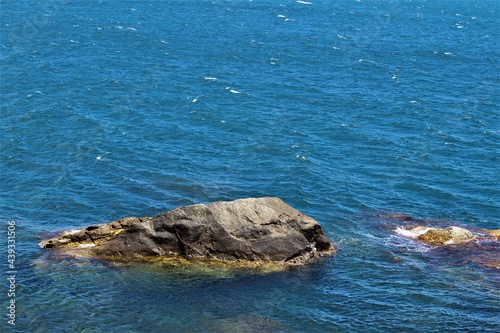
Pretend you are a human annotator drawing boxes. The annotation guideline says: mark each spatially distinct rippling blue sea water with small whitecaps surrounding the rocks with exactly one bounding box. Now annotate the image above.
[0,0,500,333]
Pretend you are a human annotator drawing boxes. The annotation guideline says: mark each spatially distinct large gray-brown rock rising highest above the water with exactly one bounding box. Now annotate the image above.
[40,197,334,265]
